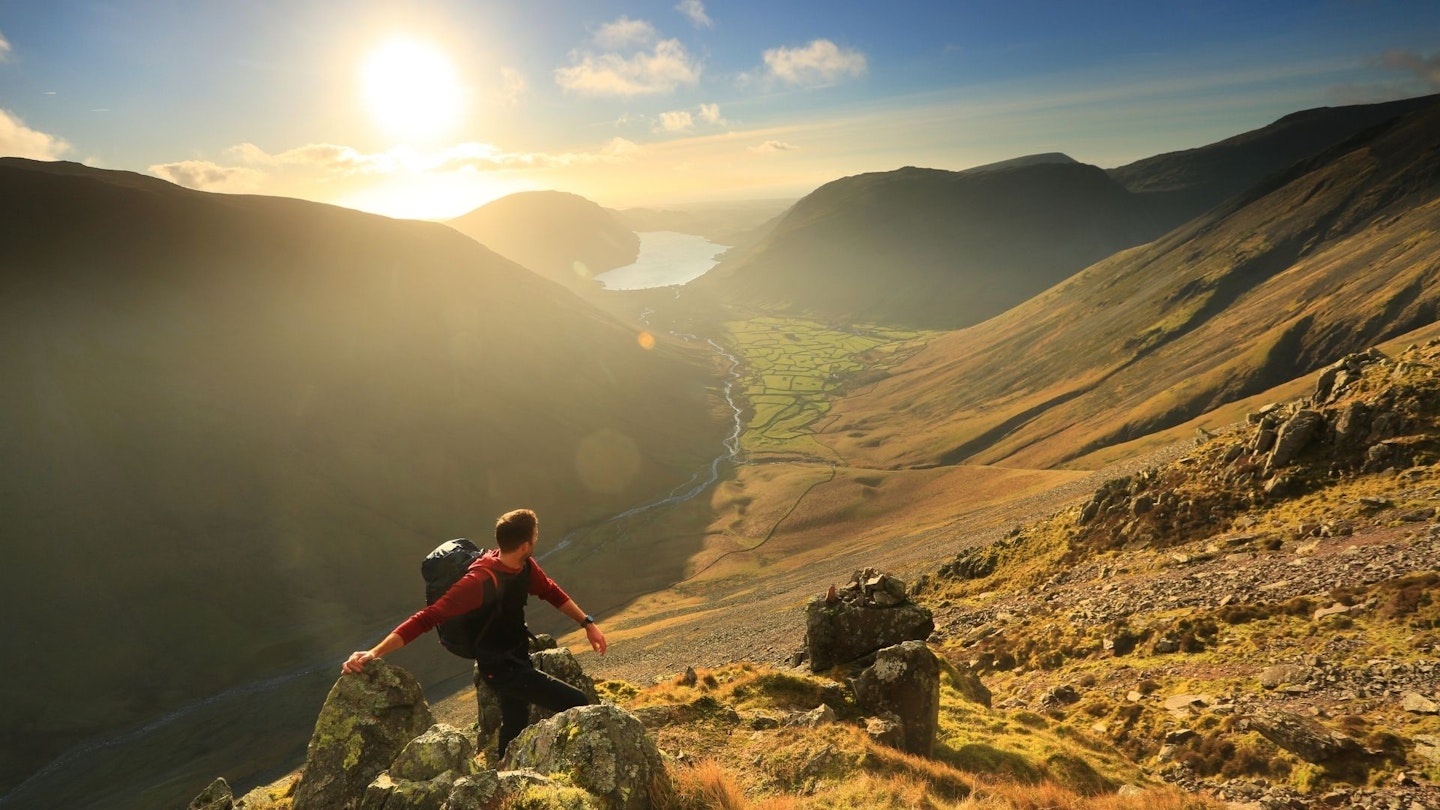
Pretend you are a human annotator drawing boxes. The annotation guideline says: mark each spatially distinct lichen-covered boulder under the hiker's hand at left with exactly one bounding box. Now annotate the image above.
[295,659,435,810]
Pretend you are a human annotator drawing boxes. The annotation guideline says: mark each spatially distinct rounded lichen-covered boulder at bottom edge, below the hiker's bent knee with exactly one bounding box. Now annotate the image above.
[507,703,671,810]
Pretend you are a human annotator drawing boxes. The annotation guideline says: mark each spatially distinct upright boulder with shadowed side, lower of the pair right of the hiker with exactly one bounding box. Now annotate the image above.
[851,641,940,757]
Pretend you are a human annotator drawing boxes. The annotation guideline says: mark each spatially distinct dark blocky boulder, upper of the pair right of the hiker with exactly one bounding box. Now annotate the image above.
[805,568,935,672]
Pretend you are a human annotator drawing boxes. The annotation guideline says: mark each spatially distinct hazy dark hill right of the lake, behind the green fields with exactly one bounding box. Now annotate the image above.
[691,156,1161,329]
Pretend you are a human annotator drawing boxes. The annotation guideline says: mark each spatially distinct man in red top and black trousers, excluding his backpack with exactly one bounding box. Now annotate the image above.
[341,509,606,757]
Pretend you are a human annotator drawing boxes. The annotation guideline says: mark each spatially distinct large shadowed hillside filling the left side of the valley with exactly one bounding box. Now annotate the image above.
[0,159,720,787]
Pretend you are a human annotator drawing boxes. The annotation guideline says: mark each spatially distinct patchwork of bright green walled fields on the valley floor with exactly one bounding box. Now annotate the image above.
[726,317,933,460]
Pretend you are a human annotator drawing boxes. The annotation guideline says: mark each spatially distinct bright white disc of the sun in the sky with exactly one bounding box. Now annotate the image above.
[361,37,465,141]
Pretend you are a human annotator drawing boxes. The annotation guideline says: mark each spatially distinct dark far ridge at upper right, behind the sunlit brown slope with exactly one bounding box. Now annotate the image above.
[1109,95,1440,225]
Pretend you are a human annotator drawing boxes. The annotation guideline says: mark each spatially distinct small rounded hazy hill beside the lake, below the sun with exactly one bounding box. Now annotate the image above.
[449,192,639,288]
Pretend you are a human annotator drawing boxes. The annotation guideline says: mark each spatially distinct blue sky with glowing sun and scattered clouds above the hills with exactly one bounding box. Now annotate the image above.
[0,0,1440,216]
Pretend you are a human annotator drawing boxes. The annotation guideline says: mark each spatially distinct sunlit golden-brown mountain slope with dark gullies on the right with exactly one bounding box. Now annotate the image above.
[821,100,1440,467]
